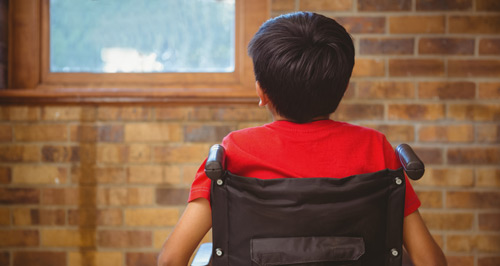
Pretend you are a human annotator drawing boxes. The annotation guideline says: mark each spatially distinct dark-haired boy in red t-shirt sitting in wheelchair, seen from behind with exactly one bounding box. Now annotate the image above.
[159,12,446,266]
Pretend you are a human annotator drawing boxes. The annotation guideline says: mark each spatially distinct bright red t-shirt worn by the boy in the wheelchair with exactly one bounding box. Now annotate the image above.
[189,120,420,216]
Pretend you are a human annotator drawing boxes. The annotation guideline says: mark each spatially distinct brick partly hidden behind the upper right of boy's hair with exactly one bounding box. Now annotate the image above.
[335,16,386,34]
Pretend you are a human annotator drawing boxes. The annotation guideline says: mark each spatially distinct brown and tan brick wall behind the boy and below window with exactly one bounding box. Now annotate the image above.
[0,0,500,266]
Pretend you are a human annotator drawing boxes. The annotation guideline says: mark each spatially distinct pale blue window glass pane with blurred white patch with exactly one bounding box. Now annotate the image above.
[50,0,235,73]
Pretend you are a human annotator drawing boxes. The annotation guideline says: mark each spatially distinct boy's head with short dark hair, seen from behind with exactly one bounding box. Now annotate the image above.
[248,12,354,123]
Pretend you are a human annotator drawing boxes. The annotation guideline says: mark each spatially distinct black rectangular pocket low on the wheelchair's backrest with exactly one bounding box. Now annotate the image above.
[250,237,365,266]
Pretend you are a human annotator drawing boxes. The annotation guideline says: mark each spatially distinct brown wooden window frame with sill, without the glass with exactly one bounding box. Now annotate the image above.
[0,0,270,103]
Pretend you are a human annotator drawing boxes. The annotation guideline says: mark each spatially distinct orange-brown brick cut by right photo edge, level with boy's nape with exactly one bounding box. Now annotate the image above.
[448,104,500,122]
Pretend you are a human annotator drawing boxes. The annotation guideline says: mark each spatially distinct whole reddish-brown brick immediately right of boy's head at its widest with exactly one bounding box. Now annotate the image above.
[359,38,415,55]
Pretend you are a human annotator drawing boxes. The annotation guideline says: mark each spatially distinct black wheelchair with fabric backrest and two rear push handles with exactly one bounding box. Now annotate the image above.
[191,144,425,266]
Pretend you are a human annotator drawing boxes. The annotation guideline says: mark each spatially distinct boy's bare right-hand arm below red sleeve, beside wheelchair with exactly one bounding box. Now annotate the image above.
[403,210,447,266]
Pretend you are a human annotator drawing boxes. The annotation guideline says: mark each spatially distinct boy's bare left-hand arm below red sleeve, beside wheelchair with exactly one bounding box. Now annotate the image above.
[158,198,212,266]
